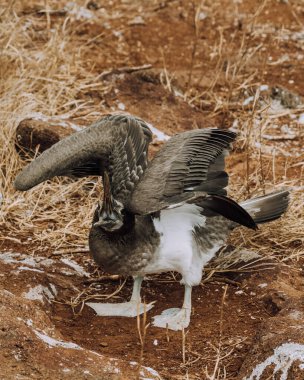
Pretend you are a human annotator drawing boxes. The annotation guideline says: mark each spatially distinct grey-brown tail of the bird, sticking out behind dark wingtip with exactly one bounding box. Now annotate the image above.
[240,190,289,223]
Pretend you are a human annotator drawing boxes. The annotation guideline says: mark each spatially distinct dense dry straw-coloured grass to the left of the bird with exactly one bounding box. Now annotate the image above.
[0,2,103,249]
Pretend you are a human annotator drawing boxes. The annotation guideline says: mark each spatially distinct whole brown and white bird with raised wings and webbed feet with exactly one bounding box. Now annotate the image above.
[14,113,289,331]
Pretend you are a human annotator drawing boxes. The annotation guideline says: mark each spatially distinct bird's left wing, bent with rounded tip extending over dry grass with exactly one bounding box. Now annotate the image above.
[15,114,152,203]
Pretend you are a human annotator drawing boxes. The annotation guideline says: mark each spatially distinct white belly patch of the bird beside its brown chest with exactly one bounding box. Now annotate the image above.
[145,204,206,274]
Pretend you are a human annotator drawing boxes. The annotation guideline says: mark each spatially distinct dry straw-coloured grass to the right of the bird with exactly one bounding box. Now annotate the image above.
[187,0,304,268]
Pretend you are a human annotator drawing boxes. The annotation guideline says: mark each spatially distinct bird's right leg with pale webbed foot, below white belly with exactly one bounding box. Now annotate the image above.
[153,285,192,330]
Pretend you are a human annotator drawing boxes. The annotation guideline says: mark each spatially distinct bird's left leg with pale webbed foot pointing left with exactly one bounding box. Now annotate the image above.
[86,277,153,317]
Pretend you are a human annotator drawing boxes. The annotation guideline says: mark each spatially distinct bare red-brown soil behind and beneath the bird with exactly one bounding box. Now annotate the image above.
[0,0,304,380]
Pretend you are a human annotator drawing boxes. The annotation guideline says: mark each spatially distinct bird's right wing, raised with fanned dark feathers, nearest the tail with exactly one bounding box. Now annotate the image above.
[128,129,255,228]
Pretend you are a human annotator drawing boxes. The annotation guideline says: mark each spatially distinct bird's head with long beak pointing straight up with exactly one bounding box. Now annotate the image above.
[94,171,124,232]
